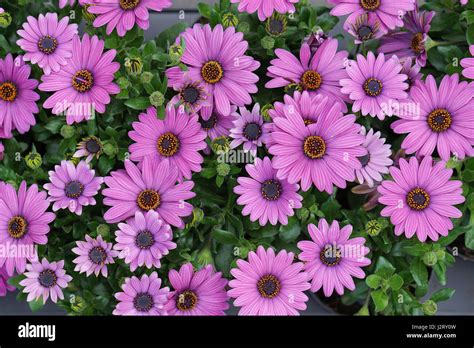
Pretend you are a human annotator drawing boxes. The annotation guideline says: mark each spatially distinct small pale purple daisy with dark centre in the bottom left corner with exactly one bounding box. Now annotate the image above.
[20,258,72,303]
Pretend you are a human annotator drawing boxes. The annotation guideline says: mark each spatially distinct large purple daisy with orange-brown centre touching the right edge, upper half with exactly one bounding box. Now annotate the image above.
[392,74,474,161]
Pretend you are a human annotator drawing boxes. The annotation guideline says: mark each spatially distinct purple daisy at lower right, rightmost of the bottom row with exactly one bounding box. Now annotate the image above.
[298,219,370,297]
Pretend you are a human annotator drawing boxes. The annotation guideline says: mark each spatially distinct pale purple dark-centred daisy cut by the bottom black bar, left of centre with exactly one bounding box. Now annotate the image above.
[113,272,170,316]
